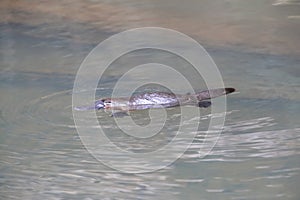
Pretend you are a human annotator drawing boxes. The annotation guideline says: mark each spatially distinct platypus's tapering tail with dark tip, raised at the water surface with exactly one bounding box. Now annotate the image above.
[195,88,235,101]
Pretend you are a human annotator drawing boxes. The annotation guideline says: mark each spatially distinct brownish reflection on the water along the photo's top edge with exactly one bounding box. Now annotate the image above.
[1,0,300,55]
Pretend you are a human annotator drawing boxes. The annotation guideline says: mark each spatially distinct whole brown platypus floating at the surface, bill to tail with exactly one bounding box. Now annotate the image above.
[75,88,235,113]
